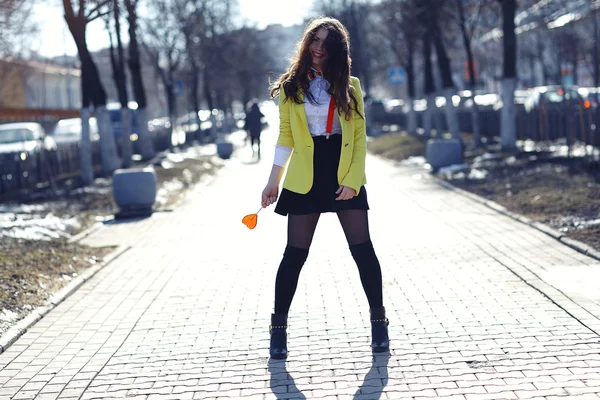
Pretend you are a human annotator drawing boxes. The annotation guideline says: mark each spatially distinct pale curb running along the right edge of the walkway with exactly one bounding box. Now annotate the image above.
[431,170,600,261]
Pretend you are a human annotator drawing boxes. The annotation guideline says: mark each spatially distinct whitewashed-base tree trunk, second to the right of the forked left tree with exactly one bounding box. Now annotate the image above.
[125,0,155,160]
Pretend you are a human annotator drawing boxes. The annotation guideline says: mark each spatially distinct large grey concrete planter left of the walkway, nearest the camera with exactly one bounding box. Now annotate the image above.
[112,167,157,218]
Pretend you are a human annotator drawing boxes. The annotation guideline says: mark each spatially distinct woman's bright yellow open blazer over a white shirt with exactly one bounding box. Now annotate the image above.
[277,76,367,194]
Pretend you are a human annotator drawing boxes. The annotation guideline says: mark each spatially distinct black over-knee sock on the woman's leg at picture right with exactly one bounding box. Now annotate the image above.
[350,240,383,308]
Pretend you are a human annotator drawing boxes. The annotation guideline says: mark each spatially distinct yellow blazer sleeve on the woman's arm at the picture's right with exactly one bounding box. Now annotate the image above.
[341,77,367,194]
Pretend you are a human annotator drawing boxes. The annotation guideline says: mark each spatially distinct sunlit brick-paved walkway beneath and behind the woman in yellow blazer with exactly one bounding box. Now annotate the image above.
[0,108,600,400]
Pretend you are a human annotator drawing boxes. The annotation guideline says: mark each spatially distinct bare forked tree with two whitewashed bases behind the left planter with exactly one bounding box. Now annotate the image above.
[63,0,120,184]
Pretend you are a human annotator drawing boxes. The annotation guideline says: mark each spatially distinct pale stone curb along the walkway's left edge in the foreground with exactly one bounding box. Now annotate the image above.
[0,244,130,354]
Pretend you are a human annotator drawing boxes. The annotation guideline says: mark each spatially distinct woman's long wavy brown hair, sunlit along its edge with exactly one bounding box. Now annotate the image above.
[270,17,364,120]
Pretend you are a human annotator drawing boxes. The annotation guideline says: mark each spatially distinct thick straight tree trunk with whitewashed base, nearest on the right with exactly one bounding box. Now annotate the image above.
[500,0,516,151]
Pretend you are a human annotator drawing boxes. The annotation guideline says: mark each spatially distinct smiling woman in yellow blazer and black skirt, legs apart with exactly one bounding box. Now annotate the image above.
[262,17,389,358]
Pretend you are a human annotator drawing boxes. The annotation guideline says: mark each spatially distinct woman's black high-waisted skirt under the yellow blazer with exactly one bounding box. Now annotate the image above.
[275,134,369,215]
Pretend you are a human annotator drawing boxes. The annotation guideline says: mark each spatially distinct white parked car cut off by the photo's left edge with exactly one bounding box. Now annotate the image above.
[0,122,56,160]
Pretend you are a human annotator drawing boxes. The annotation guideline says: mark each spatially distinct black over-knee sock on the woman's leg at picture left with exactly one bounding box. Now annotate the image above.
[275,245,308,314]
